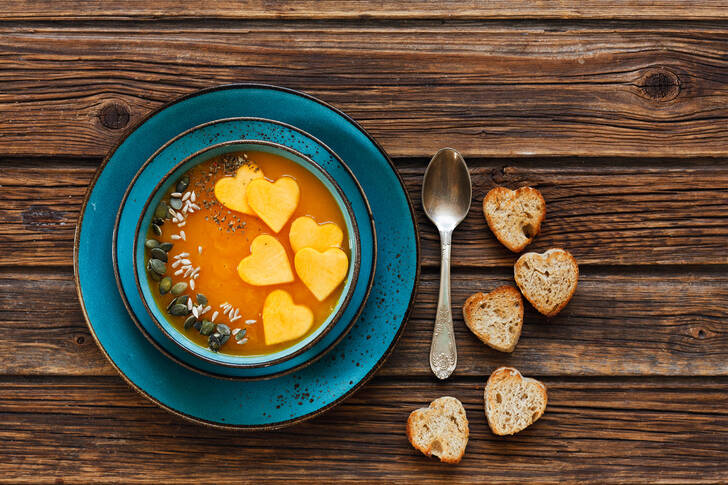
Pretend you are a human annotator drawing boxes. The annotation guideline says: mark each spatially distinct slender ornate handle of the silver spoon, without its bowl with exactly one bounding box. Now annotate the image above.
[430,231,458,379]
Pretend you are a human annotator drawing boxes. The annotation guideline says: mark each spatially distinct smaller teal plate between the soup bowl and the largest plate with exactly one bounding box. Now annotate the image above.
[114,118,376,379]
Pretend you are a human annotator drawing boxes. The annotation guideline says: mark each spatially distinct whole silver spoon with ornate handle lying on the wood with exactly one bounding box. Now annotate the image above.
[422,148,472,379]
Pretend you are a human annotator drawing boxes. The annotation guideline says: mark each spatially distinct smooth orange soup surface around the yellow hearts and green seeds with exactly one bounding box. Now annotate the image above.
[146,152,351,356]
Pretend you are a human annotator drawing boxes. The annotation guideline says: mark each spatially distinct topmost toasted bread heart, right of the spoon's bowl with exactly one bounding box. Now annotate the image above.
[483,187,546,253]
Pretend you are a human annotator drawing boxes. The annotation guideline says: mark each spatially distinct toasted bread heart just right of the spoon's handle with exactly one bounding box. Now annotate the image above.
[463,286,523,352]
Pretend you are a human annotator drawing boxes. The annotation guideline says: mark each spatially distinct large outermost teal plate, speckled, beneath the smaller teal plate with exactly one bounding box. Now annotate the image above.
[74,85,420,429]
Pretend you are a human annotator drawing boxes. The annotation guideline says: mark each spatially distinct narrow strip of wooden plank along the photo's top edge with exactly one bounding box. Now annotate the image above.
[0,0,728,20]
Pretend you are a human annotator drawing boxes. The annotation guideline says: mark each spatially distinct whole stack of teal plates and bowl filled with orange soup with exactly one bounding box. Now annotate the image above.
[74,85,419,429]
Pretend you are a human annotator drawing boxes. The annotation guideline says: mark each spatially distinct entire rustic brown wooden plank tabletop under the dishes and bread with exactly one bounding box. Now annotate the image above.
[0,0,728,483]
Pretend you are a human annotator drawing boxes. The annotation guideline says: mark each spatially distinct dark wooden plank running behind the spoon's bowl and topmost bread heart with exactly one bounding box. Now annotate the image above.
[0,159,728,267]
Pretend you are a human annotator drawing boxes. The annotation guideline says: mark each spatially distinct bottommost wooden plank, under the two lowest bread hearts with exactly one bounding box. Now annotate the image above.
[0,378,728,483]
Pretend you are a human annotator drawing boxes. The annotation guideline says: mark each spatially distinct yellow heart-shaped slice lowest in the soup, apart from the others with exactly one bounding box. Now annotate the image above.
[263,290,313,345]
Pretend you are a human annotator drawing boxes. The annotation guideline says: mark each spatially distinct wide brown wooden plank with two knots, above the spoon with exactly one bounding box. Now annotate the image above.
[0,23,728,157]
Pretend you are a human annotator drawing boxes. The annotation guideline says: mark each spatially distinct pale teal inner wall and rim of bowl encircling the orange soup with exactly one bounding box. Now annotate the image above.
[133,140,361,368]
